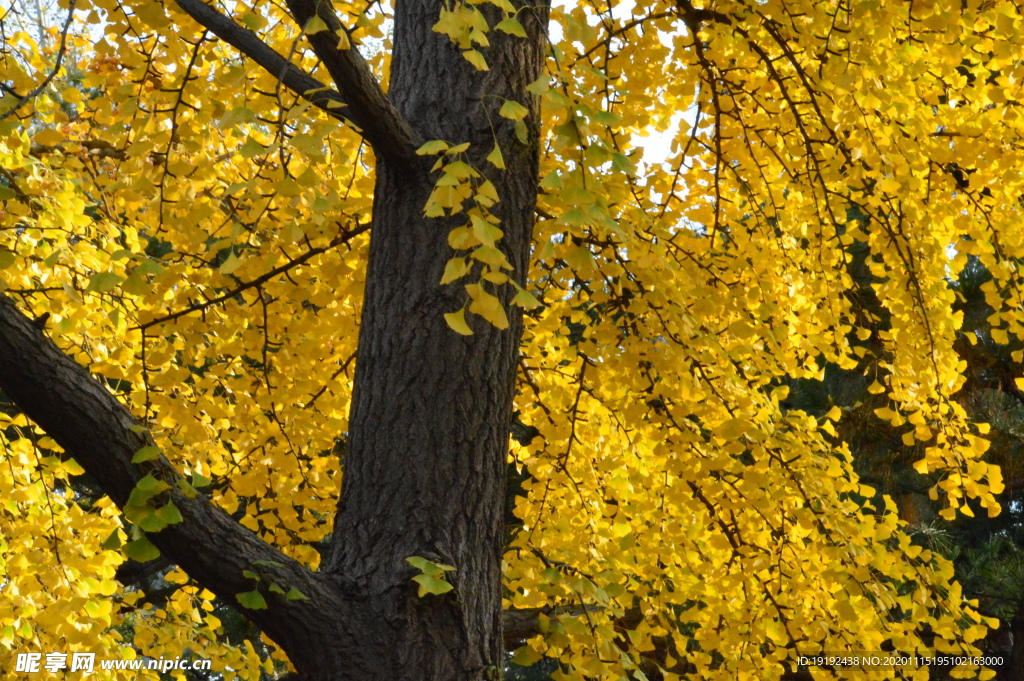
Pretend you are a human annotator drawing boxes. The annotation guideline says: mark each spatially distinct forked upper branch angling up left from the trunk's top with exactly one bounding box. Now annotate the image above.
[176,0,420,167]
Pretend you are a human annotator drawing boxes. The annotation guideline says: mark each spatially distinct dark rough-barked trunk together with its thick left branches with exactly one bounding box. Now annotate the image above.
[0,0,548,681]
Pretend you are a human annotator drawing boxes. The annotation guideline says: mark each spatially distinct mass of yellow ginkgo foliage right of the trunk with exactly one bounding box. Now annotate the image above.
[497,1,1024,679]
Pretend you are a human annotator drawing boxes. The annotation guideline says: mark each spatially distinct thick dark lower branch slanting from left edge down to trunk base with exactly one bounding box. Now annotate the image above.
[0,295,337,650]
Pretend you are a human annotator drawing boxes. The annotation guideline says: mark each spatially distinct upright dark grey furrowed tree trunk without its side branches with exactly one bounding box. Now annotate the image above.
[310,0,546,681]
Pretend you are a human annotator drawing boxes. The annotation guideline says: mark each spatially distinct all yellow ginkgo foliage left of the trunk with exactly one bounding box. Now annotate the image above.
[0,0,384,667]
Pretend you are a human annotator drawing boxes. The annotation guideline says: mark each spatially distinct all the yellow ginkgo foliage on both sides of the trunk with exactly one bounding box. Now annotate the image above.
[0,0,1024,679]
